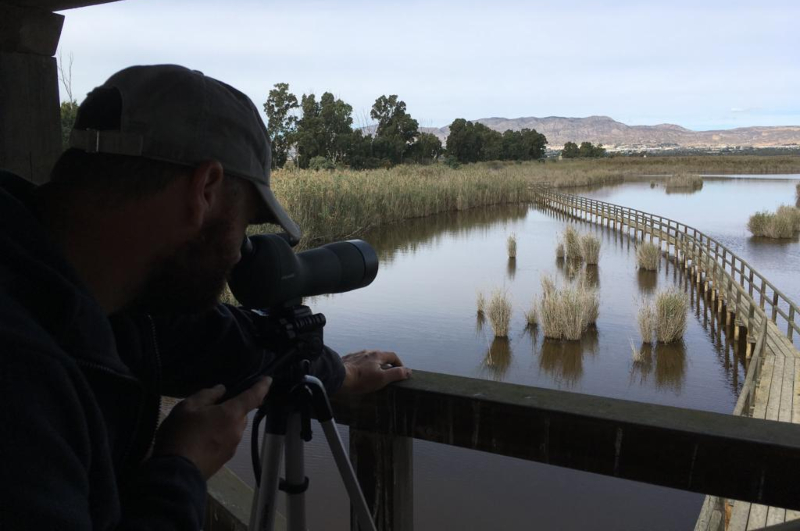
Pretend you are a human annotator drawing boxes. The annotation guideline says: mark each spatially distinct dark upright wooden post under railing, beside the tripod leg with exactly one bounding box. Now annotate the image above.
[350,428,414,531]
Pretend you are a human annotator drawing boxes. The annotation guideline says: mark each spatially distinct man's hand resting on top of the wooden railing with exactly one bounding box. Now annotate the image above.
[339,350,411,394]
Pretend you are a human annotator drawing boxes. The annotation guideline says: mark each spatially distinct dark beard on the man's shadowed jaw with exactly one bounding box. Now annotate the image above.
[129,215,233,315]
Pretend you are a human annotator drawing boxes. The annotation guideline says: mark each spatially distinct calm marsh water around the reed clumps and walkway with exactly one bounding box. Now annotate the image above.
[227,174,800,530]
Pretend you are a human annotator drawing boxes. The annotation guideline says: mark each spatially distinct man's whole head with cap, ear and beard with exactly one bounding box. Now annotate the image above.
[45,65,300,313]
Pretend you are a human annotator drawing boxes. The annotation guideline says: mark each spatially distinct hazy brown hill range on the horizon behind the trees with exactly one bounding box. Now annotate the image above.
[406,116,800,148]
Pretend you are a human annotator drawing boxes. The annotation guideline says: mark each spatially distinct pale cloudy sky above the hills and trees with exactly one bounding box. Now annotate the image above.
[59,0,800,130]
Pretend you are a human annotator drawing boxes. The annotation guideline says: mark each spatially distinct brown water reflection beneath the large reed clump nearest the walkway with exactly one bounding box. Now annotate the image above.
[631,341,686,393]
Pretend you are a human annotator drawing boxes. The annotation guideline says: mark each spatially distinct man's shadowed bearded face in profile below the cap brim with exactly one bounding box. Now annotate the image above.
[128,177,258,315]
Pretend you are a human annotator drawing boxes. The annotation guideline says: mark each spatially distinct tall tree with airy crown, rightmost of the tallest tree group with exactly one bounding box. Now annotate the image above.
[369,94,419,164]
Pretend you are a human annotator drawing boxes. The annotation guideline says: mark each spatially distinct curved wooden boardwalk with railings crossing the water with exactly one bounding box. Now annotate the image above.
[537,186,800,531]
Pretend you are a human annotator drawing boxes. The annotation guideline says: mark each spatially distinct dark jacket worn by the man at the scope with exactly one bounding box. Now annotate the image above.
[0,172,344,531]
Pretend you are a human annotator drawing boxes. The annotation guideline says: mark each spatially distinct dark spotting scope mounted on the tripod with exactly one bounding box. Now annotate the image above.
[228,234,378,309]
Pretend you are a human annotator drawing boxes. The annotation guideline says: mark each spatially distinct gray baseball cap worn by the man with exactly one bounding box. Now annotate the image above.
[70,65,302,242]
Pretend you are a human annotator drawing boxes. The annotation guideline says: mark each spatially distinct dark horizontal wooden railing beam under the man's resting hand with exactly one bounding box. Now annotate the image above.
[334,371,800,509]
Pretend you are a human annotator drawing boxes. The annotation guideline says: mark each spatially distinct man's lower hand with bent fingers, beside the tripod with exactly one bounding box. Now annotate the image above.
[153,377,272,479]
